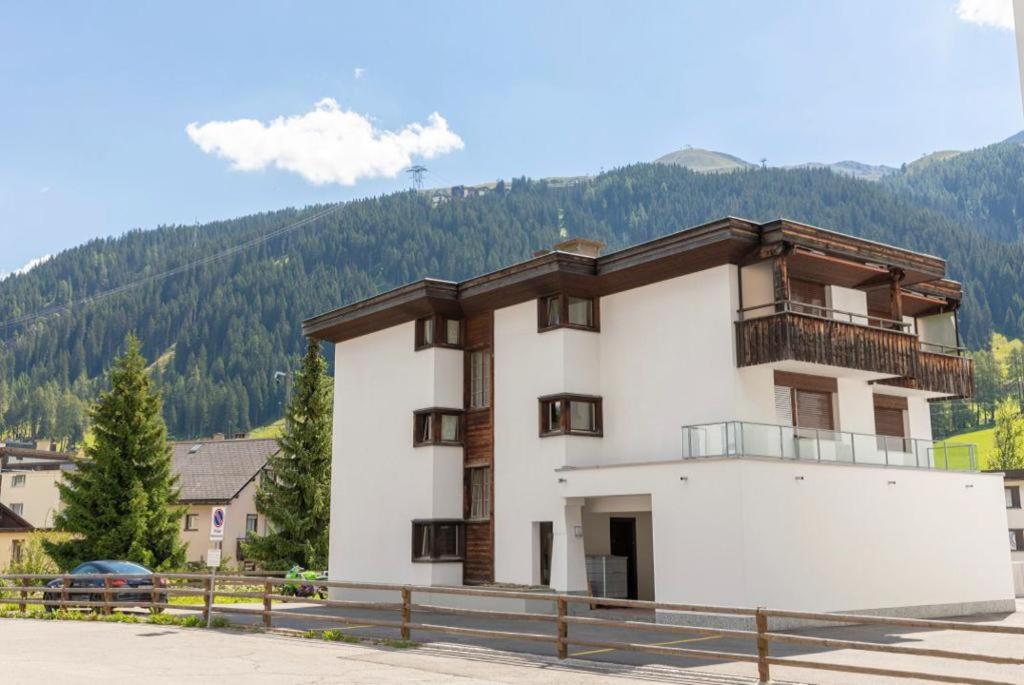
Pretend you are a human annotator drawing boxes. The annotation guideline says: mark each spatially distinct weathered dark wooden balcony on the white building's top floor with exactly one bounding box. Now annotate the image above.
[736,300,974,397]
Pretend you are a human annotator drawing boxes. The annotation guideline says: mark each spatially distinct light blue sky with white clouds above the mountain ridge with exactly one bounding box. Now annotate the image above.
[0,0,1024,273]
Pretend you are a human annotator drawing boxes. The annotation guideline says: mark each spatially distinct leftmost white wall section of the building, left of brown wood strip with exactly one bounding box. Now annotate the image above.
[330,323,463,585]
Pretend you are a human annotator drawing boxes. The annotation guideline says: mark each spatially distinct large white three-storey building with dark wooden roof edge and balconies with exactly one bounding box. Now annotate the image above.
[303,218,1014,618]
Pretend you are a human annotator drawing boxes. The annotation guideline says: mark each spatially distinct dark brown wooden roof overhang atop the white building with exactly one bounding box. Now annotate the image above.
[302,217,958,342]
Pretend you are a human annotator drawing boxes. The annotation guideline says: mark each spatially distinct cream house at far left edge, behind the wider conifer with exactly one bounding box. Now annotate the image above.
[0,445,75,528]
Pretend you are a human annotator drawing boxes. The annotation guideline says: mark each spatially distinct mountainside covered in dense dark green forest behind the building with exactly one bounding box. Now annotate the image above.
[0,145,1024,437]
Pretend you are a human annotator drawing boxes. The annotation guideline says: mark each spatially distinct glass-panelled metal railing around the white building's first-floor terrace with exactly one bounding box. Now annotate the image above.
[682,421,978,471]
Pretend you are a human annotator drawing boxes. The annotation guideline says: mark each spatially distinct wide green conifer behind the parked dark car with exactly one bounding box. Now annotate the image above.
[44,335,185,570]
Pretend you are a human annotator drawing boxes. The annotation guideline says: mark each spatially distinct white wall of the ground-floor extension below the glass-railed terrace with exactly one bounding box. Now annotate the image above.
[558,459,1013,611]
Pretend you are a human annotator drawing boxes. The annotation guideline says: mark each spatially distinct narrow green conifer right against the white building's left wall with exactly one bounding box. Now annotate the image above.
[244,340,331,569]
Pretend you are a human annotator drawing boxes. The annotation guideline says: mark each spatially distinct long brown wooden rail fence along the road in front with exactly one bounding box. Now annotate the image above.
[0,573,1024,685]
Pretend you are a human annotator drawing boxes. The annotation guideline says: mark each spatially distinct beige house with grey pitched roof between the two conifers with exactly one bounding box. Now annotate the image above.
[172,438,278,562]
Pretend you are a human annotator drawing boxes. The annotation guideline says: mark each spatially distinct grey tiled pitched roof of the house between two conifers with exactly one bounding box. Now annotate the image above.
[171,439,278,502]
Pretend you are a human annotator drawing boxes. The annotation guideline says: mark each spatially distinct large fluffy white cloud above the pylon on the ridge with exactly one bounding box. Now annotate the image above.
[185,97,464,185]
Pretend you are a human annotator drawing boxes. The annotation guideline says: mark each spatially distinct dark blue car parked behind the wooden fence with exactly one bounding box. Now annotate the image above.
[43,560,167,612]
